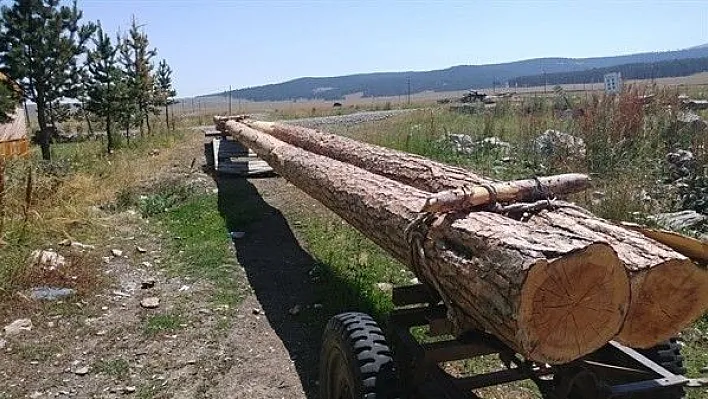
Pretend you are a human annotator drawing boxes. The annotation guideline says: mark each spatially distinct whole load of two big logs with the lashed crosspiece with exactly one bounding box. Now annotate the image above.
[215,117,708,364]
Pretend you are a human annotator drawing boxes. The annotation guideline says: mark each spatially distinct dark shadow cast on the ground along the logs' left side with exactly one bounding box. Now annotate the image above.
[215,176,384,398]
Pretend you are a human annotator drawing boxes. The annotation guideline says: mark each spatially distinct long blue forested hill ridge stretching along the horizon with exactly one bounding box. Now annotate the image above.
[205,45,708,101]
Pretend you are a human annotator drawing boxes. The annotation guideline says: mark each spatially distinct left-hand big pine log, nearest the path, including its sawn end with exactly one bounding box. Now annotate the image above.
[224,121,629,364]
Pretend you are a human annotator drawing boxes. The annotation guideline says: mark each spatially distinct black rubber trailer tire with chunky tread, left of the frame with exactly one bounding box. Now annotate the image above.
[319,312,400,399]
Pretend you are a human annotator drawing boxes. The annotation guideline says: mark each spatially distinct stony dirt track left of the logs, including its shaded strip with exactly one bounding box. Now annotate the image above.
[0,134,319,399]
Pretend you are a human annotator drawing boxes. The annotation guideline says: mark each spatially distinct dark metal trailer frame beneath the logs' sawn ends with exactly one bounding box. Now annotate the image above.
[388,284,700,399]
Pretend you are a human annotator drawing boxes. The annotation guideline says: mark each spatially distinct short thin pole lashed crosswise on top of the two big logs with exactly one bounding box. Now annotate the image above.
[422,173,590,212]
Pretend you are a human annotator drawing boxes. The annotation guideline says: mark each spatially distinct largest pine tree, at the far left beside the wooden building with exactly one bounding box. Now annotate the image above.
[0,0,95,160]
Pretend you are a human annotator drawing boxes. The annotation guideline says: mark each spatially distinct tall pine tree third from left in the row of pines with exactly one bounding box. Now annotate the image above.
[121,17,157,134]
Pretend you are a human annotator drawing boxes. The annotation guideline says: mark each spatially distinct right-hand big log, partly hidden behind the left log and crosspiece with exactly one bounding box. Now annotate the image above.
[245,120,708,348]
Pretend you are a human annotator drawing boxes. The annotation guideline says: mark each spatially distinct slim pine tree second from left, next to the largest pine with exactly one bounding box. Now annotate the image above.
[86,23,123,153]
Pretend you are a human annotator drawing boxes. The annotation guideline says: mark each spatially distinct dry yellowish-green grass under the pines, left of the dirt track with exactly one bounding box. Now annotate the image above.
[0,126,188,297]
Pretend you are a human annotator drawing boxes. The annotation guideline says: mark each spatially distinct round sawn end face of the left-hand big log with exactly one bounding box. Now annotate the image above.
[519,244,630,364]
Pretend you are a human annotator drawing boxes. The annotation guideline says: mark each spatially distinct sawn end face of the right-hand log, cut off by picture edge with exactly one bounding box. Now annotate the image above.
[617,259,708,348]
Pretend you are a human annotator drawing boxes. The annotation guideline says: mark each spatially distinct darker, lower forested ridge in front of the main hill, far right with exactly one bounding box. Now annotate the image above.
[509,57,708,87]
